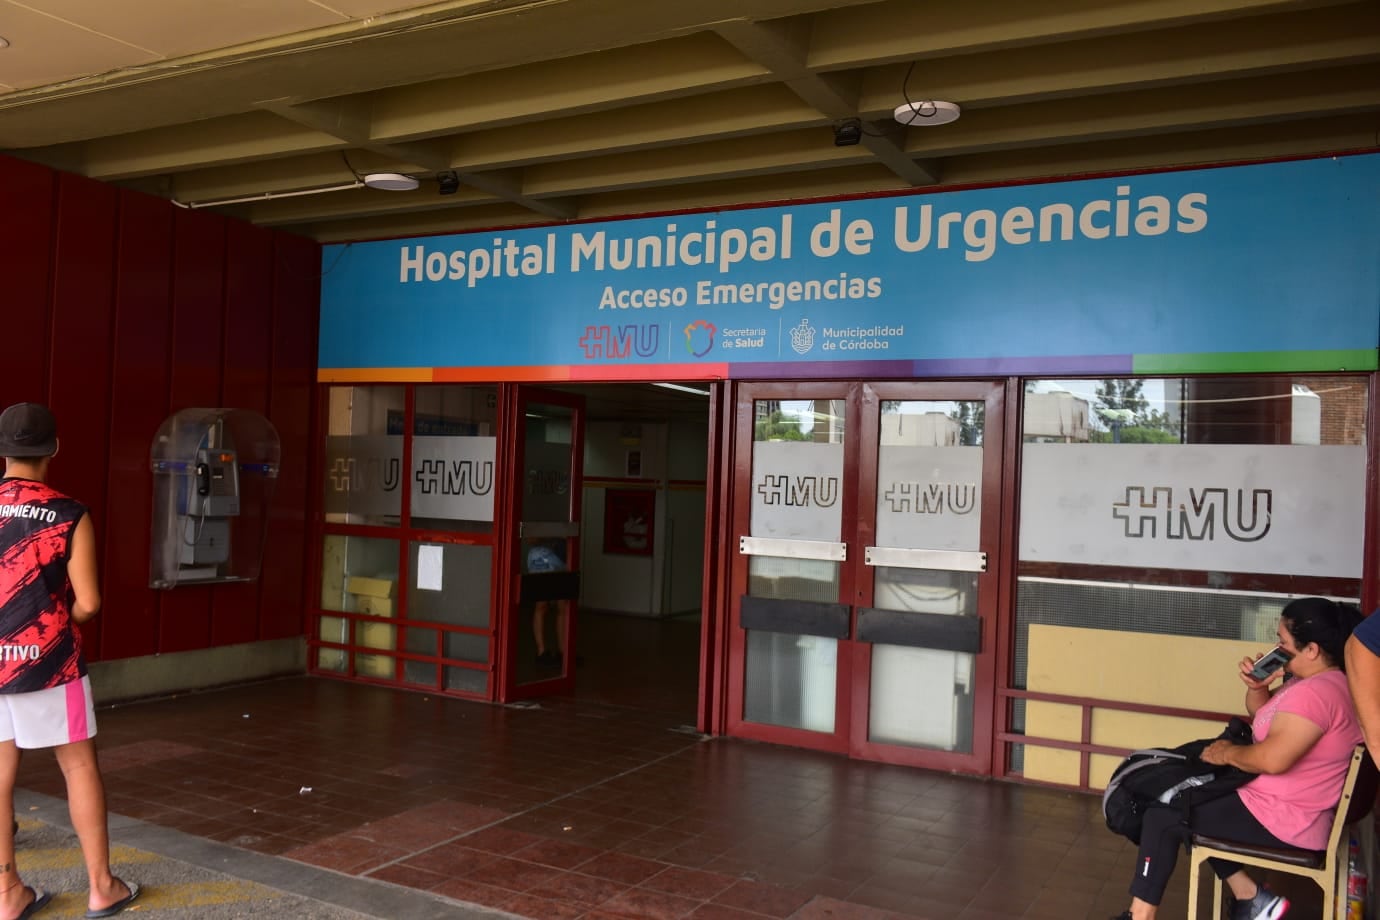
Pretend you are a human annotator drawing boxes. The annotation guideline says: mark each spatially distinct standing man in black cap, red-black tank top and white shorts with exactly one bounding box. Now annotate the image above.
[0,403,139,919]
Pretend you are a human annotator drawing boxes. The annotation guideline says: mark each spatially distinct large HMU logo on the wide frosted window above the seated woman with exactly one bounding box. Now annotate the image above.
[1112,486,1274,543]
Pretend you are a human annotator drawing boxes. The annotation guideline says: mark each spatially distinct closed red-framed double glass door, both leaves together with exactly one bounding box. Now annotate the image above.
[729,382,1002,772]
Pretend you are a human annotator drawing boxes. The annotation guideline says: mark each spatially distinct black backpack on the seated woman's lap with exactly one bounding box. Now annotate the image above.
[1103,717,1256,844]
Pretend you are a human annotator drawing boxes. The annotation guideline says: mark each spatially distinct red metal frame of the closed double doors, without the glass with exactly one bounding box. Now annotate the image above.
[719,381,1009,775]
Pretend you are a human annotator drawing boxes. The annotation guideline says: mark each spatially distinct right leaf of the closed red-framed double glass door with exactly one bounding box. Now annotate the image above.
[850,382,1002,772]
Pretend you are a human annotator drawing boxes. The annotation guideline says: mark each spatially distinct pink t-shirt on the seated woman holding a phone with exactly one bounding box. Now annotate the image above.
[1236,670,1361,850]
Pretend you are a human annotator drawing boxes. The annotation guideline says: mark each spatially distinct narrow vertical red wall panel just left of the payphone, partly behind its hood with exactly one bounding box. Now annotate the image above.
[100,192,173,658]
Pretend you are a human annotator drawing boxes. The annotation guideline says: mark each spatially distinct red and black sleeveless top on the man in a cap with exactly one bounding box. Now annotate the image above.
[0,479,86,694]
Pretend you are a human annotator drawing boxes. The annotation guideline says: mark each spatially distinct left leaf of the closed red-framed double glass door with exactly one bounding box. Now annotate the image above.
[729,383,857,752]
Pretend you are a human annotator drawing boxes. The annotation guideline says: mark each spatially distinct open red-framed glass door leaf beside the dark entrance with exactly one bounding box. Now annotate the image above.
[502,386,584,701]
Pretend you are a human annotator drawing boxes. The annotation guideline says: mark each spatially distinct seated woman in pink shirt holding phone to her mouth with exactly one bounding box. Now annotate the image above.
[1115,597,1361,920]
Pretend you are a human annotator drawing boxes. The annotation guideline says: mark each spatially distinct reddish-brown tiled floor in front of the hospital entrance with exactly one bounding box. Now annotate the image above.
[10,615,1308,920]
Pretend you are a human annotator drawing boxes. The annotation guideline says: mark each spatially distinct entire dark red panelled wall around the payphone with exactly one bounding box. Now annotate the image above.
[0,156,320,659]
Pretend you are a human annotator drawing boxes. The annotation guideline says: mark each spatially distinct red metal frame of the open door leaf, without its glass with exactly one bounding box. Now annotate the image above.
[495,383,585,702]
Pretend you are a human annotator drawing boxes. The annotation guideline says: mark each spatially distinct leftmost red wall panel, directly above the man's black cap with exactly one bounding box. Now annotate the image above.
[0,157,57,406]
